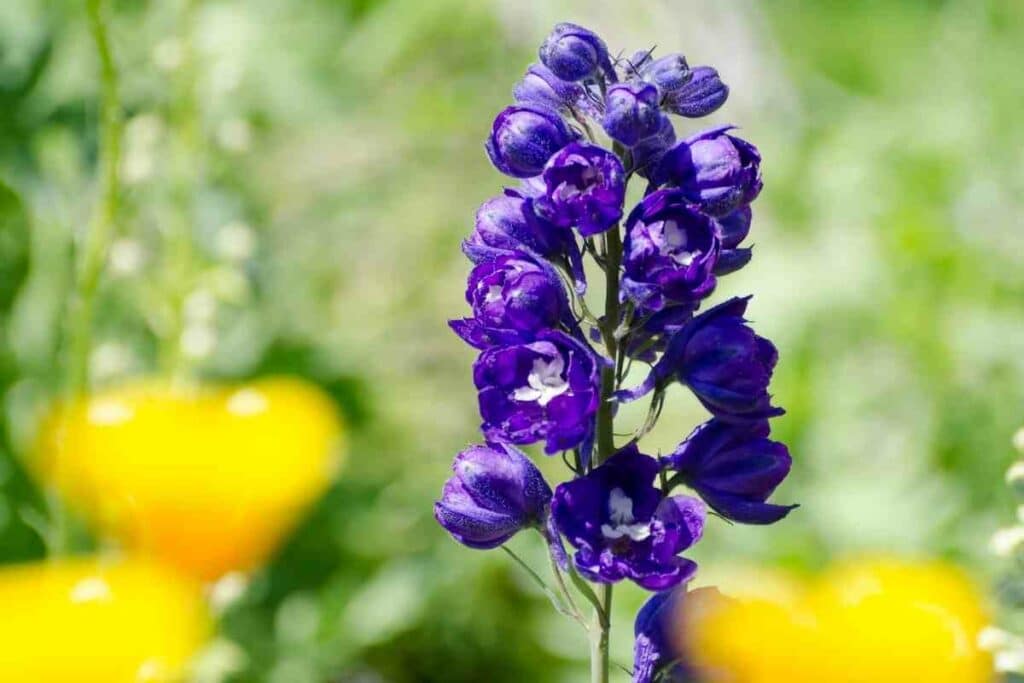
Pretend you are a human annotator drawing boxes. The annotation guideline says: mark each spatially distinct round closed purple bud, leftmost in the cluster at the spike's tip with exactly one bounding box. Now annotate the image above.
[485,104,579,178]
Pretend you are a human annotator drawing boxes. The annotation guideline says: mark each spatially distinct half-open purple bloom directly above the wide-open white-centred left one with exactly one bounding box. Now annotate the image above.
[449,254,568,349]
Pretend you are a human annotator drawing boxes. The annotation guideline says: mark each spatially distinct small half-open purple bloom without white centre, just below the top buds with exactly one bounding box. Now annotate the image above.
[537,142,626,237]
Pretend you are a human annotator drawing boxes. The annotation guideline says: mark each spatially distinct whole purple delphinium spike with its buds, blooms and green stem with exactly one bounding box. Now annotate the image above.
[435,24,795,683]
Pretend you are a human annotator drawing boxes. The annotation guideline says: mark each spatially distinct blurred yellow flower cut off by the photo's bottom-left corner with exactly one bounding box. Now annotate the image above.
[0,558,211,683]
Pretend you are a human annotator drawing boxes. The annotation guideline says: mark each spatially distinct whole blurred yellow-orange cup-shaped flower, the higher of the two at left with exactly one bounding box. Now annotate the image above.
[38,378,341,580]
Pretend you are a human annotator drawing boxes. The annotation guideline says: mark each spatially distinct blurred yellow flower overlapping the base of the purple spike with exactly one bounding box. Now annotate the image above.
[679,559,994,683]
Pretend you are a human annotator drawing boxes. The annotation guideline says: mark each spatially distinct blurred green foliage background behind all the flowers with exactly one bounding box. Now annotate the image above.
[0,0,1024,683]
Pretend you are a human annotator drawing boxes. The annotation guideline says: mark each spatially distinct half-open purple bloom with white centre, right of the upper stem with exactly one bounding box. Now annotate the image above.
[623,189,721,311]
